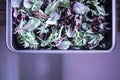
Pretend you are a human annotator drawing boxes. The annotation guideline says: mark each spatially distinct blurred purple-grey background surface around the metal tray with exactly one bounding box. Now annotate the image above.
[0,0,120,80]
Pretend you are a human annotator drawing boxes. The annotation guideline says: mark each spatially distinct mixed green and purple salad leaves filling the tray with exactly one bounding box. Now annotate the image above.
[11,0,111,50]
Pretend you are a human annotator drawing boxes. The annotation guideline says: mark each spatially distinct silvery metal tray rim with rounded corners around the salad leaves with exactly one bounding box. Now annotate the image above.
[6,0,116,53]
